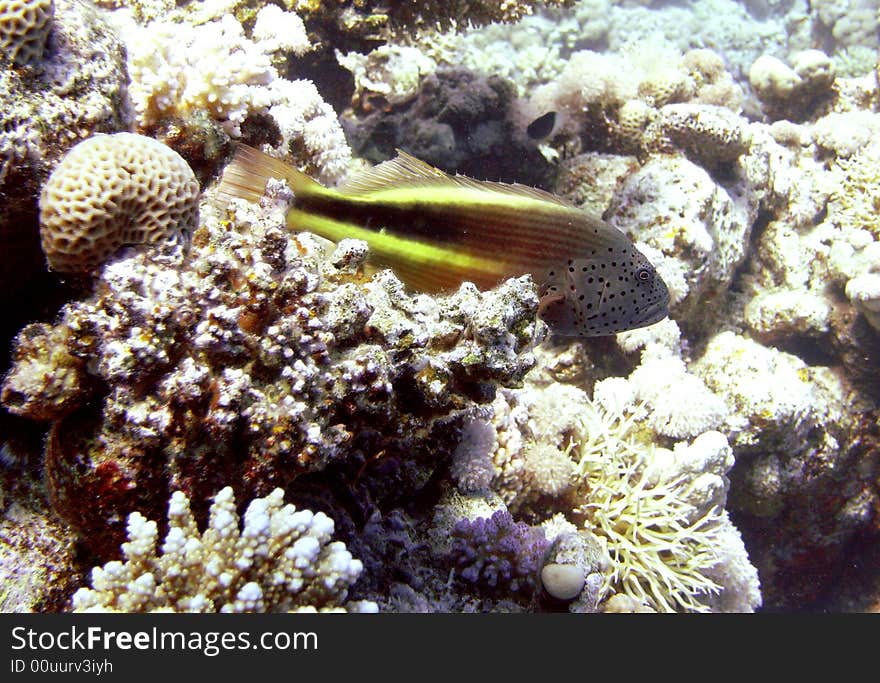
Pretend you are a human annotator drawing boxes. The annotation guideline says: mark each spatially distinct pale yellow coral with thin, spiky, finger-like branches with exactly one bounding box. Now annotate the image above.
[572,406,725,612]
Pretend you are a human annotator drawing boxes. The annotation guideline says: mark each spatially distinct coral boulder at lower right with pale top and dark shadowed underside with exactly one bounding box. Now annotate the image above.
[693,332,877,600]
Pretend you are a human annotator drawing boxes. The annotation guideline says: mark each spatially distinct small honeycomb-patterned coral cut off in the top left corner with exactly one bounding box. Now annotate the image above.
[0,0,55,66]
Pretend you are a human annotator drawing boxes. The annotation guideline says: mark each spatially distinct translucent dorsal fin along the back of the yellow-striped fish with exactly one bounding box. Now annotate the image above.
[338,149,574,208]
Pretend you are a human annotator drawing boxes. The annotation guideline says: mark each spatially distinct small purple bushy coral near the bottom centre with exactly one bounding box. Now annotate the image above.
[450,510,549,594]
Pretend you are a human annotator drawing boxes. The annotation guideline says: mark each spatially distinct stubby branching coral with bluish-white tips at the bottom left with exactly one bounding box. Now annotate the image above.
[73,487,376,612]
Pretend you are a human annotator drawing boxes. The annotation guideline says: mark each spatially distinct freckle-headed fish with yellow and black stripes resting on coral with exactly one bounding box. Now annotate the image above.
[219,145,669,337]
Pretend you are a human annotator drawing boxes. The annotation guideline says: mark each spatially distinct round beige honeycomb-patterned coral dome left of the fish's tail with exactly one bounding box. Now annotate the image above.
[40,133,199,272]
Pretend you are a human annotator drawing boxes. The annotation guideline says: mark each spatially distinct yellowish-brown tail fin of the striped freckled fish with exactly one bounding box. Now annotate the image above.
[217,144,333,202]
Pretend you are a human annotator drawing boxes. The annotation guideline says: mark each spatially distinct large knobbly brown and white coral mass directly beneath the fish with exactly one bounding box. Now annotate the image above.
[3,175,538,555]
